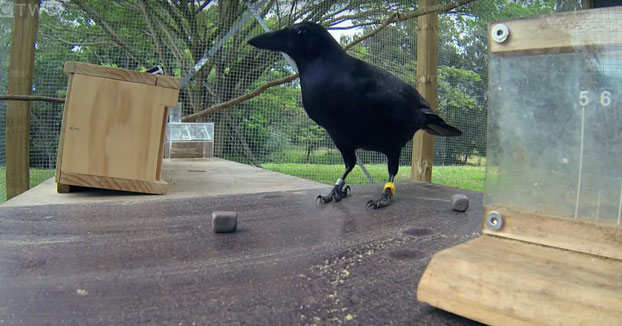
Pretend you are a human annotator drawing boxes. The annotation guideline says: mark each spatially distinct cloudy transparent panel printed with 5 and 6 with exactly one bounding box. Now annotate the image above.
[485,45,622,226]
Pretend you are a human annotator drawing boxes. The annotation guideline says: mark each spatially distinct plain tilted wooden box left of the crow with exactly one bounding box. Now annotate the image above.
[56,62,180,194]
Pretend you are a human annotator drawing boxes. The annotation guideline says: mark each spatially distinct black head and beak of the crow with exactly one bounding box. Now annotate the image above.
[248,22,343,63]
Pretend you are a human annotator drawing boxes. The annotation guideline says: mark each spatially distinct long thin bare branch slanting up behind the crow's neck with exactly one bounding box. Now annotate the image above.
[181,0,477,122]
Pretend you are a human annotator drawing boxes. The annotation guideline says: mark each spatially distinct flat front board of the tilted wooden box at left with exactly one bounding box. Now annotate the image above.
[61,74,178,182]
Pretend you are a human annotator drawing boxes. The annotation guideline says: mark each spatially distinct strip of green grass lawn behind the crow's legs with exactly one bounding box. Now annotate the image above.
[262,164,484,191]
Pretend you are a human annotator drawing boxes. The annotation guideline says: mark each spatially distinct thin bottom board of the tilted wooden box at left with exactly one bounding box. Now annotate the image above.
[57,172,168,195]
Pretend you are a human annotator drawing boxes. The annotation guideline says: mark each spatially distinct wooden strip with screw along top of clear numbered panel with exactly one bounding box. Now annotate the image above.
[488,7,622,55]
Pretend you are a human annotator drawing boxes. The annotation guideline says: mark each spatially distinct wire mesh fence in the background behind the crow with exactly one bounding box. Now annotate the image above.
[0,0,579,201]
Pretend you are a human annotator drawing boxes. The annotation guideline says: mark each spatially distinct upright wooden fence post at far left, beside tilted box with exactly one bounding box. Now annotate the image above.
[5,0,40,199]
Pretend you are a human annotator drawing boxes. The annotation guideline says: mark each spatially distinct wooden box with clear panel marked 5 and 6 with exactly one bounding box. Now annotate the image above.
[417,7,622,326]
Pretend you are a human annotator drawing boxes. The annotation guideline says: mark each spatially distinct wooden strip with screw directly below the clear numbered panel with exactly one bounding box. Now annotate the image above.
[483,207,622,260]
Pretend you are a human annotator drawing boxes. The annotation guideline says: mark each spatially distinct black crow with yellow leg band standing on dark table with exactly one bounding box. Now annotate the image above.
[248,22,462,208]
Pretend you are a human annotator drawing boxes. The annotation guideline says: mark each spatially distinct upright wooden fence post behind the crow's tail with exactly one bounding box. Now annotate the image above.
[410,0,438,182]
